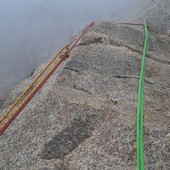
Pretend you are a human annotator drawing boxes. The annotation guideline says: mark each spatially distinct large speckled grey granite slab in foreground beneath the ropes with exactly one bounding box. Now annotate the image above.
[0,22,170,170]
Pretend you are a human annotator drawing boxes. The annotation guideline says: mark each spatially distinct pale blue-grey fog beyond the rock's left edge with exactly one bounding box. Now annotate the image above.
[0,0,133,95]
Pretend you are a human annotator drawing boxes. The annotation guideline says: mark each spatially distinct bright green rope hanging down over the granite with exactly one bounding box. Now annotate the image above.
[136,21,149,170]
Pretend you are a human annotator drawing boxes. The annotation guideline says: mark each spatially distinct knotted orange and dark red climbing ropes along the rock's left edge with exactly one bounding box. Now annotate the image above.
[0,22,94,135]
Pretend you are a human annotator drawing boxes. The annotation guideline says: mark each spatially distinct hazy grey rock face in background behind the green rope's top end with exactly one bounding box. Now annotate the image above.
[120,0,170,36]
